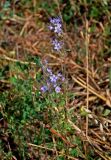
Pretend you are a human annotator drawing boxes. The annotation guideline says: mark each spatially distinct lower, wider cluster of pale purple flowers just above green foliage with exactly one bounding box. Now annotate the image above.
[41,61,65,93]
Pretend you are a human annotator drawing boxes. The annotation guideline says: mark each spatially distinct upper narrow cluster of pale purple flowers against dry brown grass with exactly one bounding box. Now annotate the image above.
[48,17,63,52]
